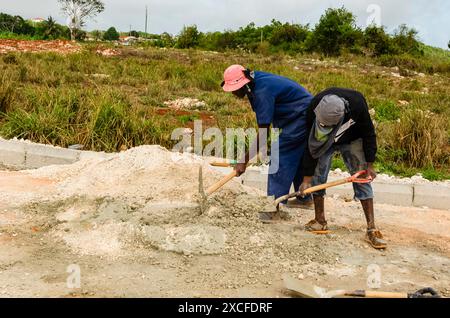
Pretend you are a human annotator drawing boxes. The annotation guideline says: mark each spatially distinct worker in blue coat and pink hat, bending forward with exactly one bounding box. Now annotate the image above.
[222,65,313,208]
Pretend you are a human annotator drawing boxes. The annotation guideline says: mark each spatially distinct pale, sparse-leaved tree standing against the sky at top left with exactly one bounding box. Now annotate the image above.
[58,0,105,40]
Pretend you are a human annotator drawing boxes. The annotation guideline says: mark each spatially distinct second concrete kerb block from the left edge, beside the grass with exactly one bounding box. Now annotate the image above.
[25,144,81,169]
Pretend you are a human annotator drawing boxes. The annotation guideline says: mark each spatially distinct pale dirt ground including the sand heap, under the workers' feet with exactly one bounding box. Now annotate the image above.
[0,147,450,297]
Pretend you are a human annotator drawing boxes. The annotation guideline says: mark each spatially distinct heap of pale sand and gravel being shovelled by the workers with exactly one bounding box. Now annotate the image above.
[28,146,270,257]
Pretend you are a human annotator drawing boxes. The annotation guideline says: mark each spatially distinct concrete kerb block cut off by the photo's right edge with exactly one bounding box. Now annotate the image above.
[413,184,450,210]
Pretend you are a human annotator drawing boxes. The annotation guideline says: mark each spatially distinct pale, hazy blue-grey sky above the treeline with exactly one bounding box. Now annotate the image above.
[0,0,450,48]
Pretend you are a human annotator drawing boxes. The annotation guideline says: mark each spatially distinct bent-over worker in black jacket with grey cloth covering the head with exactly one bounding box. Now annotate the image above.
[300,88,386,249]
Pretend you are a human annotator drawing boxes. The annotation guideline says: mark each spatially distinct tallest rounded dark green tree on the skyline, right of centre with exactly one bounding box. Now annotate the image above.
[309,7,362,55]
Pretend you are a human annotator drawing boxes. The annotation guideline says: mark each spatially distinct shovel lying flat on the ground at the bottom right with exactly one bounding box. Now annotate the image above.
[283,275,441,298]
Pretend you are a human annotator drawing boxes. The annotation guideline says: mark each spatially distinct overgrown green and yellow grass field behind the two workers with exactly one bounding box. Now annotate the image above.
[0,44,450,179]
